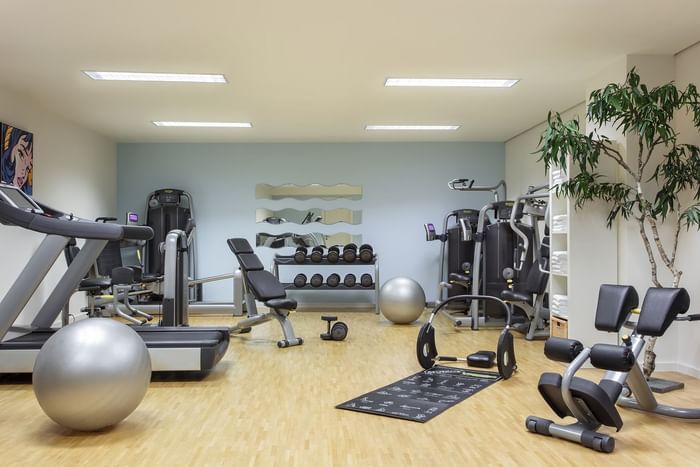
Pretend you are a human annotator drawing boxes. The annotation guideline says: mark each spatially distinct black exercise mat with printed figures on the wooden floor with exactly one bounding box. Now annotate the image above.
[336,366,502,423]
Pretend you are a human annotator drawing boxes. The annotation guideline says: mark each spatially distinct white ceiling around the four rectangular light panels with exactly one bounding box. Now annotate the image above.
[0,0,700,142]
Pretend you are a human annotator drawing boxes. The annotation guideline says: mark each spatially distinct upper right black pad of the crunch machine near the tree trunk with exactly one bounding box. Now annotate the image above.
[636,287,690,337]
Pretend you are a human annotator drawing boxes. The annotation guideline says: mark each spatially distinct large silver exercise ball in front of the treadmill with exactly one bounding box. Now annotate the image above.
[32,318,151,431]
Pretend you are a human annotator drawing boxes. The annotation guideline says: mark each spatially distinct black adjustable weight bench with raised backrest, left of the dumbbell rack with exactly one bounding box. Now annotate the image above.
[227,238,304,348]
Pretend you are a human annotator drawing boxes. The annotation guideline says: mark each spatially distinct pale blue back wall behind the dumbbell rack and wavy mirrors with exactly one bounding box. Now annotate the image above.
[117,143,505,300]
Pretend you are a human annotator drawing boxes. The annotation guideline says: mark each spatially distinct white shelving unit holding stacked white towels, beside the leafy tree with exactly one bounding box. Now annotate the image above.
[549,156,617,345]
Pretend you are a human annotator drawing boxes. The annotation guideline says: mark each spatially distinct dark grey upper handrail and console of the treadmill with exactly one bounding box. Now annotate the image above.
[0,202,153,240]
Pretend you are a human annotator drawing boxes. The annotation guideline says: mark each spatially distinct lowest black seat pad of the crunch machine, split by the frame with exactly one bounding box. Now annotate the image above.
[537,373,622,431]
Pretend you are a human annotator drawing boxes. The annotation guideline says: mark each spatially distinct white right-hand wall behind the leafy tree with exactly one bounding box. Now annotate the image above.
[506,53,700,376]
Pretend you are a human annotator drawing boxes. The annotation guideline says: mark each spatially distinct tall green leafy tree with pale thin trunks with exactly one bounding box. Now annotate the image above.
[536,69,700,377]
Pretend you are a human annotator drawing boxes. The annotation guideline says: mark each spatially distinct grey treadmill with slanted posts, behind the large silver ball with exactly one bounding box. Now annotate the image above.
[0,183,229,373]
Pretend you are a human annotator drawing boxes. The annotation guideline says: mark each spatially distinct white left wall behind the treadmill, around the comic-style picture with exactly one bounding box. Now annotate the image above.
[0,88,116,323]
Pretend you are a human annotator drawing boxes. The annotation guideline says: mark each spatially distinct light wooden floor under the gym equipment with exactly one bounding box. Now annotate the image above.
[0,311,700,467]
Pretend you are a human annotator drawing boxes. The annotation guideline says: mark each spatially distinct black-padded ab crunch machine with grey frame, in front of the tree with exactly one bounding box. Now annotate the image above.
[525,285,700,452]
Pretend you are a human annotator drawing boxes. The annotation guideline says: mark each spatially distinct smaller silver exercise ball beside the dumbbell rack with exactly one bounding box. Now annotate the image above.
[379,277,425,324]
